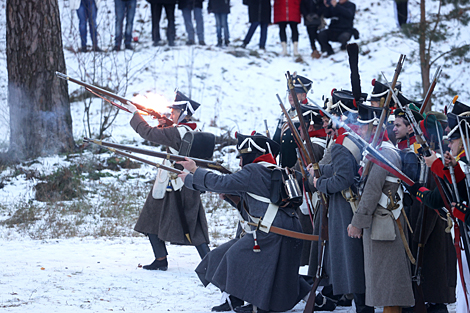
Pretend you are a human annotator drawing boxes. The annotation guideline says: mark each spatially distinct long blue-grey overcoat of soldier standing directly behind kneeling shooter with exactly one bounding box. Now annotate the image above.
[312,144,365,295]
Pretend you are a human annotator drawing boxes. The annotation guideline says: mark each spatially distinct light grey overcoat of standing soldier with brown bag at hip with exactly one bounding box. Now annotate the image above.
[351,148,415,307]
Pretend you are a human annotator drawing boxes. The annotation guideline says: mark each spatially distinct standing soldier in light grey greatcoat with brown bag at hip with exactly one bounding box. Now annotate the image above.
[347,104,415,313]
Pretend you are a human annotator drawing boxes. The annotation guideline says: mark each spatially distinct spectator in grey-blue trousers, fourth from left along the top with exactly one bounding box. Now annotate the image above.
[178,0,206,46]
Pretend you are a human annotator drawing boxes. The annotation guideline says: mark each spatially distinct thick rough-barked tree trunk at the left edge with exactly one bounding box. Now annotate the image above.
[6,0,75,160]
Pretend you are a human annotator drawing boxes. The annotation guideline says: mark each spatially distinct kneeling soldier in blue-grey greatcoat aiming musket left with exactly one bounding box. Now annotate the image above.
[178,134,311,313]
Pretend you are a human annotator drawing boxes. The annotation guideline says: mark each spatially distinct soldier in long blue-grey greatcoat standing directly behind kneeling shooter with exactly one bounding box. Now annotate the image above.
[308,98,374,312]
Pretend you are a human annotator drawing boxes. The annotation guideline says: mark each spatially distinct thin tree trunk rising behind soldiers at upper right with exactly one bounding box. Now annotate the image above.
[418,0,432,112]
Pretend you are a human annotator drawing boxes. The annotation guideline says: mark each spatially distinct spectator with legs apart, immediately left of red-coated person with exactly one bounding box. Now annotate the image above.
[242,0,271,50]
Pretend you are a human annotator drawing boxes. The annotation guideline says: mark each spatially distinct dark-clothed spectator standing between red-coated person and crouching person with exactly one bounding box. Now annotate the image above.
[300,0,325,59]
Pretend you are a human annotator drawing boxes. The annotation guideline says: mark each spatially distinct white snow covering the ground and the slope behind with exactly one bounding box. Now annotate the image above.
[0,0,470,313]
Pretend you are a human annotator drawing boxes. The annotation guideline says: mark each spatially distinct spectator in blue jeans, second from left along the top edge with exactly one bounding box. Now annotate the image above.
[113,0,137,51]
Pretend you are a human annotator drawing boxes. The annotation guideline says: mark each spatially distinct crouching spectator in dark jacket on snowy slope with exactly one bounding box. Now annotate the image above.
[318,0,357,55]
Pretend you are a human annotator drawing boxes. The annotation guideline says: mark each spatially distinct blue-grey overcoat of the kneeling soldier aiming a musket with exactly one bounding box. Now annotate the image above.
[184,163,311,312]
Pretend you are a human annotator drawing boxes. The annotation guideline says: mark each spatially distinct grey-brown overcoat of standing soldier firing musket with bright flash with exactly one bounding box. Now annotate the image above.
[131,114,209,246]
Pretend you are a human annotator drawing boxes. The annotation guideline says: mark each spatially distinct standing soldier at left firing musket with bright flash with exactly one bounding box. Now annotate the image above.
[127,91,209,271]
